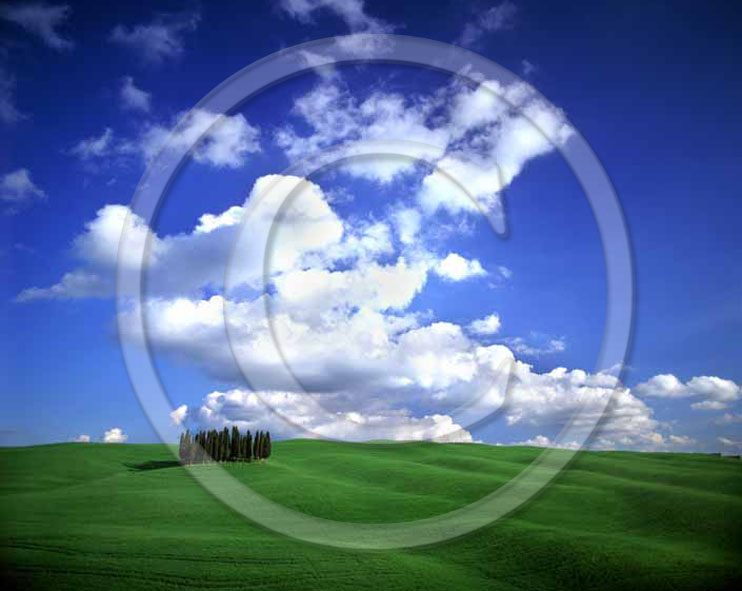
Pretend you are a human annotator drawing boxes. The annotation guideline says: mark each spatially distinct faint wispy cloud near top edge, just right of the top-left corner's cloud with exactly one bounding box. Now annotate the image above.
[109,13,201,65]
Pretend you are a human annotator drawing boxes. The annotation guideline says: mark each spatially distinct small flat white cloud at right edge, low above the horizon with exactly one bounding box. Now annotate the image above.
[634,374,742,410]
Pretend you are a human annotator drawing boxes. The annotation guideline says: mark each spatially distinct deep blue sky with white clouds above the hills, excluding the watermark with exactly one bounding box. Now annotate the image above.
[0,0,742,451]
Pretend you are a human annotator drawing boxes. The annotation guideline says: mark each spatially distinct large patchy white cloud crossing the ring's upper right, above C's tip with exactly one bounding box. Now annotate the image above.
[275,80,573,227]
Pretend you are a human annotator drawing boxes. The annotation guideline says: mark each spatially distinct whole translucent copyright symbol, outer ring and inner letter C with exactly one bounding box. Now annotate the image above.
[117,34,633,549]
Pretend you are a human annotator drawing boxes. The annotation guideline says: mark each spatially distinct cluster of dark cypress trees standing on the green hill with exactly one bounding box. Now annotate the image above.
[179,427,271,464]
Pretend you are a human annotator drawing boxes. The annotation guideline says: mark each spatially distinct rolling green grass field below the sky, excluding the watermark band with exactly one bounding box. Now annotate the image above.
[0,440,742,591]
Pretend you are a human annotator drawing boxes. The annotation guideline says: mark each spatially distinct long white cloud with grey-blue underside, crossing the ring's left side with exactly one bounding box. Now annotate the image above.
[18,175,346,301]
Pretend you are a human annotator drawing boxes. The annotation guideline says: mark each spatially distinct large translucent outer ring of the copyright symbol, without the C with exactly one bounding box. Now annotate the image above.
[116,34,633,549]
